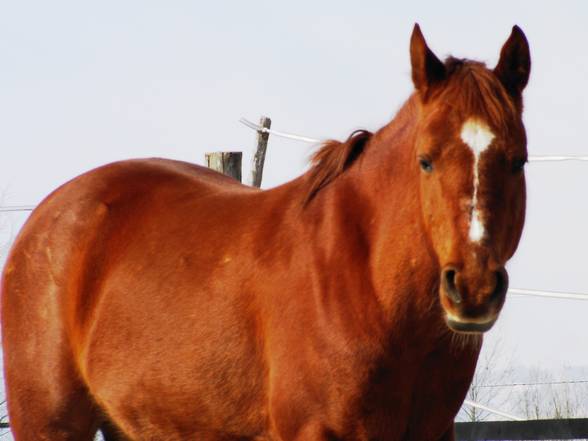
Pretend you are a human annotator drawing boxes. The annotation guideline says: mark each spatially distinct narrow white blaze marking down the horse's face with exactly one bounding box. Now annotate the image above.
[461,118,494,242]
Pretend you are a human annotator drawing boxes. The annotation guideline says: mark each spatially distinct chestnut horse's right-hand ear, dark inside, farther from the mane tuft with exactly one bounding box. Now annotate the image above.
[494,25,531,100]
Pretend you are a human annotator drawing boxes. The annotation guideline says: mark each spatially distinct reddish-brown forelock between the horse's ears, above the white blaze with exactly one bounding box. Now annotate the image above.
[439,57,522,131]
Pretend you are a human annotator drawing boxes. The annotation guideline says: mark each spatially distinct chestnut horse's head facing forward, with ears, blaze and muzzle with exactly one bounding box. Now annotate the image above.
[410,25,530,332]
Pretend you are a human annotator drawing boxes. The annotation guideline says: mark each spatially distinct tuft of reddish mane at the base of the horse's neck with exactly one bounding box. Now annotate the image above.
[304,130,372,205]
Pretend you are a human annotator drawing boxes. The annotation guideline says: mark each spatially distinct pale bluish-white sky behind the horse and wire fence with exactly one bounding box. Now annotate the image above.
[0,0,588,412]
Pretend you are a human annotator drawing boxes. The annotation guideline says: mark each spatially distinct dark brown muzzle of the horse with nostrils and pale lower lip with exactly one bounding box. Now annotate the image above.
[440,266,508,333]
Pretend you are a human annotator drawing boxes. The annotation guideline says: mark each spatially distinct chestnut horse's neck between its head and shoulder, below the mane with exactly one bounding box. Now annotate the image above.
[300,98,444,344]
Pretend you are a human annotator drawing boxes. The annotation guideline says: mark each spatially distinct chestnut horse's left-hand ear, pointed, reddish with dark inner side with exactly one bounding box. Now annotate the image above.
[410,23,446,99]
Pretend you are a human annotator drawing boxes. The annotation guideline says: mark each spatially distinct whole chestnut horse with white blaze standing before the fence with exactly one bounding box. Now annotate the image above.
[1,24,530,441]
